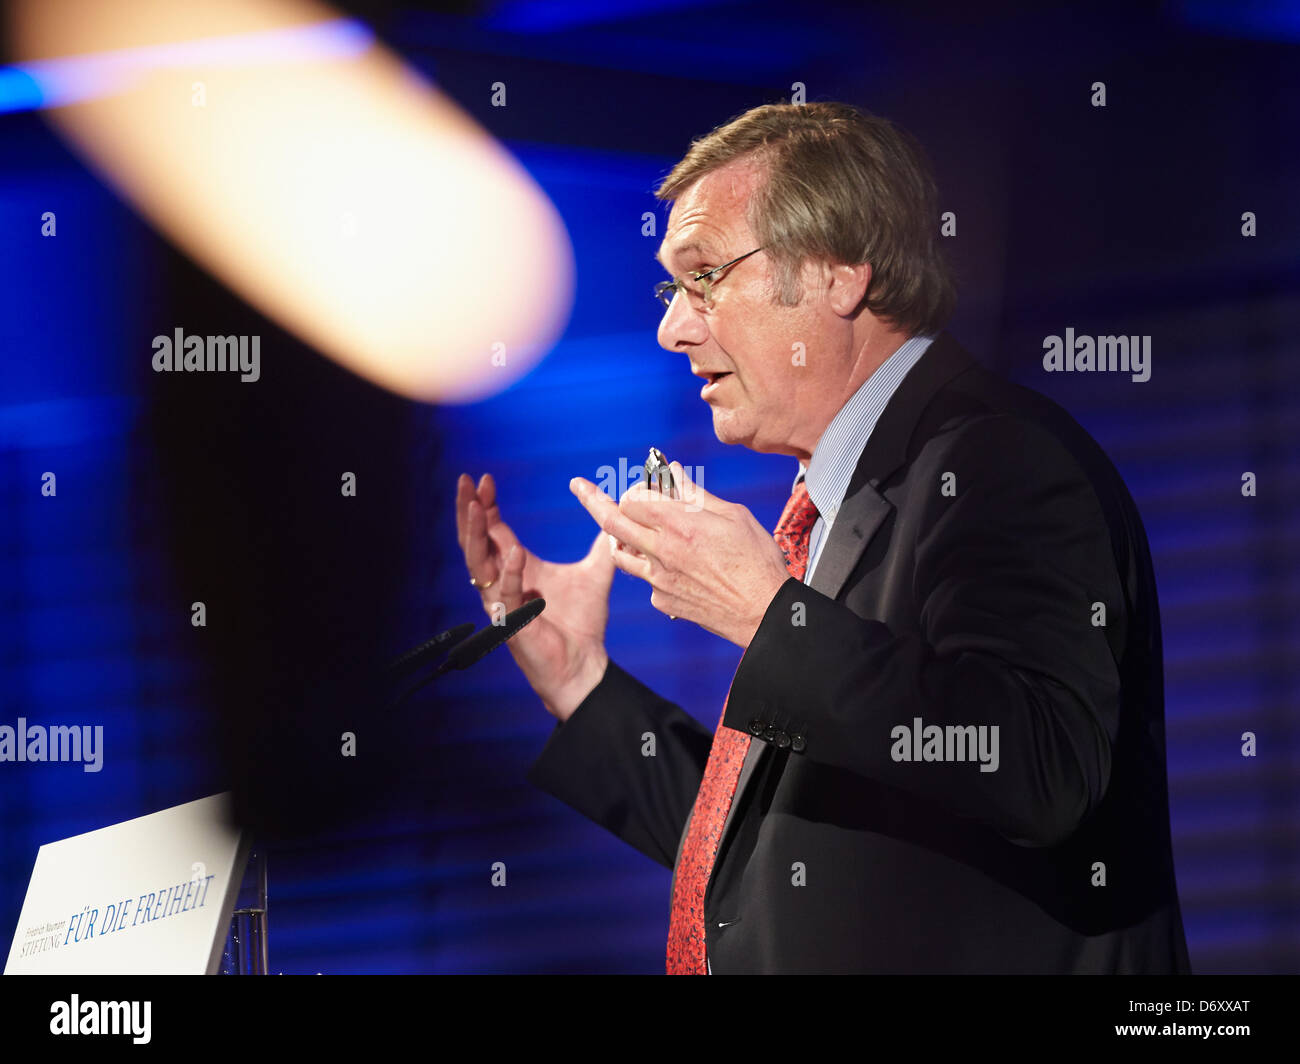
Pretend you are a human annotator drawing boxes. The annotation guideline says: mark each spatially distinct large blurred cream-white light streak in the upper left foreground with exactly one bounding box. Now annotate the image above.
[0,0,573,402]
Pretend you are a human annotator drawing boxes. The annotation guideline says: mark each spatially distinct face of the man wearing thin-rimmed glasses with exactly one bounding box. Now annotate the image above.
[658,160,845,454]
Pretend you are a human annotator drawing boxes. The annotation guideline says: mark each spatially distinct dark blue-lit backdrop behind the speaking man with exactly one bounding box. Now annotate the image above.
[0,0,1300,973]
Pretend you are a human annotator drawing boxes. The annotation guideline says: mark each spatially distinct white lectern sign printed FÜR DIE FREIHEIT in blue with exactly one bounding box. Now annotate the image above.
[4,795,248,976]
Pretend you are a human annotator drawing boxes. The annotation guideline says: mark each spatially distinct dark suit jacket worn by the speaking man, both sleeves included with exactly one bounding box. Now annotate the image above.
[529,333,1190,974]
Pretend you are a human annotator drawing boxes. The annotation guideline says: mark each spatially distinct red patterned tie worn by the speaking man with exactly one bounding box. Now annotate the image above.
[668,479,818,976]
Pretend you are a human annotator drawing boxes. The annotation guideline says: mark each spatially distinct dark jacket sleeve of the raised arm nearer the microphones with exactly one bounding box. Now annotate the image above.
[528,659,714,868]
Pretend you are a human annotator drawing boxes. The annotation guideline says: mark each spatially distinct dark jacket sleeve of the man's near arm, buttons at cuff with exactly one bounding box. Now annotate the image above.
[724,416,1125,845]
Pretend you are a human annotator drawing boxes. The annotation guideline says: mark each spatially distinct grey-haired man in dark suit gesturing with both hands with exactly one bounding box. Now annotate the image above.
[458,104,1188,973]
